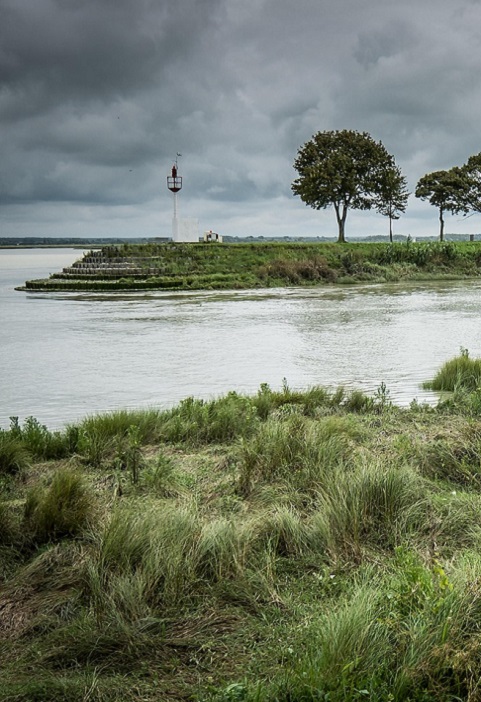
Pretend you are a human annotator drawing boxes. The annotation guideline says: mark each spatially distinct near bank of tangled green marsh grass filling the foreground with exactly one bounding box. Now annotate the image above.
[0,372,481,702]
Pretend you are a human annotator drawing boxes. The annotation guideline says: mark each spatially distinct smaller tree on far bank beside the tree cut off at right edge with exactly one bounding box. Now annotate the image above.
[415,166,470,241]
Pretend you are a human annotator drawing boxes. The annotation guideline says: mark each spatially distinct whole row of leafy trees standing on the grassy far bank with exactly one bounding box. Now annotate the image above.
[292,130,481,242]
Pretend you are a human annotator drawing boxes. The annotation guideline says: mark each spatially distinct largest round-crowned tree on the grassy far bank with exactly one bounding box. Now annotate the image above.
[292,130,398,242]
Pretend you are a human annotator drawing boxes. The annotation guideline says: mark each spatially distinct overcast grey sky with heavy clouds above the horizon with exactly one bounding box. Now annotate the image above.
[0,0,481,239]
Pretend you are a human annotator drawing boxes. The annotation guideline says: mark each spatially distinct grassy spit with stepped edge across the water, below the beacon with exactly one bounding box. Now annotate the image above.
[21,241,481,291]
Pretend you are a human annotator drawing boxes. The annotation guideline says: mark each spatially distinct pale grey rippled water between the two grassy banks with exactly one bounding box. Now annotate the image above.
[0,249,481,428]
